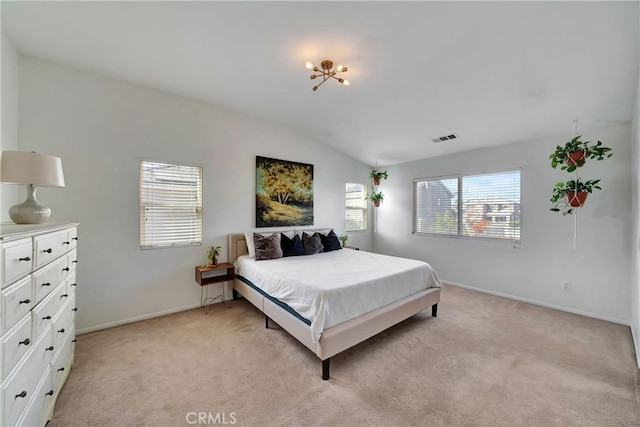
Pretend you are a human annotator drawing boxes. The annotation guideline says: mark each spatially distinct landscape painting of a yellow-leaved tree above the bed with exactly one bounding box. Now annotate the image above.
[256,156,313,227]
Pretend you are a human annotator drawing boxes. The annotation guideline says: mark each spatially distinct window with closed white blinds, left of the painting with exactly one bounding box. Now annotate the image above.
[140,160,202,249]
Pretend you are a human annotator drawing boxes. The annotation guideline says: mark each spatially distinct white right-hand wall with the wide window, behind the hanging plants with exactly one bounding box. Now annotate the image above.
[374,124,631,324]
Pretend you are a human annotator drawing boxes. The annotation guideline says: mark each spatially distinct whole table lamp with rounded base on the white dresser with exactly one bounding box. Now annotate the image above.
[0,151,64,224]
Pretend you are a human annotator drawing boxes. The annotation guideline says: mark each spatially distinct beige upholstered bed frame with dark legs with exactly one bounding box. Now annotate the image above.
[229,234,440,380]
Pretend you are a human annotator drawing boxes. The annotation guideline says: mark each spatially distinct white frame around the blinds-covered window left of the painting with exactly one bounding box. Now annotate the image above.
[138,158,204,250]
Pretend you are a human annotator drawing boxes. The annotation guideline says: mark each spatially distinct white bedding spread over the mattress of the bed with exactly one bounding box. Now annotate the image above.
[235,249,442,342]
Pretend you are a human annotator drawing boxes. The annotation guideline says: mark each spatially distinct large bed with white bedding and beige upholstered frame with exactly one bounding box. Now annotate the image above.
[229,234,441,380]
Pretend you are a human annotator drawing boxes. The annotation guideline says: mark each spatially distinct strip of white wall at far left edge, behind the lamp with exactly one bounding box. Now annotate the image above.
[0,33,19,222]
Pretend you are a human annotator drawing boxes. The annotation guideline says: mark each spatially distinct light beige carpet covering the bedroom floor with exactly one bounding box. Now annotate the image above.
[49,286,640,427]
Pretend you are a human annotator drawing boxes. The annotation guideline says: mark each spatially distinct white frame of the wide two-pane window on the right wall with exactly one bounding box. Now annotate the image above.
[411,167,522,245]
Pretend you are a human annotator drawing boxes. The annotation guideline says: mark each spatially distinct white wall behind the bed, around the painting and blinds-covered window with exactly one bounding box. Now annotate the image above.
[19,55,371,331]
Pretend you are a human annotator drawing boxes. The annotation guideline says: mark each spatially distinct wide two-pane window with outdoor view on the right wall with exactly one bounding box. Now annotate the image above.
[413,170,521,242]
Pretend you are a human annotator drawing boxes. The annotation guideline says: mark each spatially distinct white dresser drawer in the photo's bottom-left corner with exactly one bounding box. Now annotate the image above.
[0,340,44,426]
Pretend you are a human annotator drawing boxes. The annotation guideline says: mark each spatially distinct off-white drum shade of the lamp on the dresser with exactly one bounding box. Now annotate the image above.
[0,151,64,187]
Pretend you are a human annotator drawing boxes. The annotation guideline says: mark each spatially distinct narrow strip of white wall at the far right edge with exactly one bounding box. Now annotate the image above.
[631,63,640,367]
